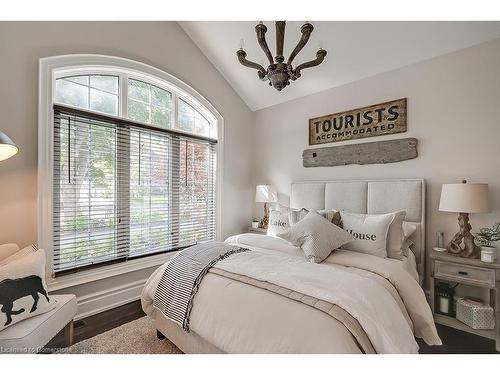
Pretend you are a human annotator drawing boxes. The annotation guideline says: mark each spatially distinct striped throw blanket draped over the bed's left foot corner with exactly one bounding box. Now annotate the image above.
[153,241,248,332]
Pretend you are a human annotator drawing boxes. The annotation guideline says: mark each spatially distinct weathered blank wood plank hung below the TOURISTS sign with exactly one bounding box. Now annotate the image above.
[302,138,418,168]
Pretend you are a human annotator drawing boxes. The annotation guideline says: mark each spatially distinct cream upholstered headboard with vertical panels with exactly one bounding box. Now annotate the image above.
[290,178,425,279]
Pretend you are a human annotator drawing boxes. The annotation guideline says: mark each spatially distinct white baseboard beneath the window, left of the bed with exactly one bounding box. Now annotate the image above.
[75,279,147,320]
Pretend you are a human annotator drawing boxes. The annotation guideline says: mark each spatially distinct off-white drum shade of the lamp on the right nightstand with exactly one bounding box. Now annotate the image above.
[439,183,490,214]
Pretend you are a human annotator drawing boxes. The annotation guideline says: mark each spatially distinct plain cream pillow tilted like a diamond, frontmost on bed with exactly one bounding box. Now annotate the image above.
[278,212,354,263]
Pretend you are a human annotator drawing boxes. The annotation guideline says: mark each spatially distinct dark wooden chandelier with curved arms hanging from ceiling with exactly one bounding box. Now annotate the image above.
[236,21,326,91]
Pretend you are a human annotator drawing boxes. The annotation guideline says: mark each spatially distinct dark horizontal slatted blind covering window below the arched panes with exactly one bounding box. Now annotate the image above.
[53,105,217,273]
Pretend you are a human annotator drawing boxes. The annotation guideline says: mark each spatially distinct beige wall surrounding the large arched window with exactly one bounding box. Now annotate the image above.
[0,22,252,245]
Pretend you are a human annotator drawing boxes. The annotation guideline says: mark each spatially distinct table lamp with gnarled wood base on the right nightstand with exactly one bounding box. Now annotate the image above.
[439,180,489,258]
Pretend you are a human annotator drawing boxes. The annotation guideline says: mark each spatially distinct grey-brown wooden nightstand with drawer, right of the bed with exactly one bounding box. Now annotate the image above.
[430,250,500,351]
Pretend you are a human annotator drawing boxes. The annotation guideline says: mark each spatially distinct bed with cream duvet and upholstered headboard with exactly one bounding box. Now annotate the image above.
[142,179,441,353]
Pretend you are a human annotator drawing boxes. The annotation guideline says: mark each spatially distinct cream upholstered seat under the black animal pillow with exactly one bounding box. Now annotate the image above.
[0,294,77,354]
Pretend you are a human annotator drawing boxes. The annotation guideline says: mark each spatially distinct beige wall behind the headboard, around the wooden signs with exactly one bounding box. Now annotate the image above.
[252,39,500,284]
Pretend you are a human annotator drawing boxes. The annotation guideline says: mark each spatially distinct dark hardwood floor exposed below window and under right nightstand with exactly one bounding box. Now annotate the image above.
[46,301,497,354]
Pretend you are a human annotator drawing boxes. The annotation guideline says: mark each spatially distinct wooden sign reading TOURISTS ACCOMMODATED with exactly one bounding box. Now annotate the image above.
[309,98,406,145]
